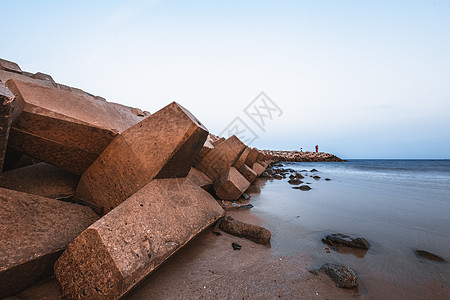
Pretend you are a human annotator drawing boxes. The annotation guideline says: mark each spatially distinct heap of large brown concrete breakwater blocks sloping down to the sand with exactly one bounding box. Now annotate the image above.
[0,59,272,299]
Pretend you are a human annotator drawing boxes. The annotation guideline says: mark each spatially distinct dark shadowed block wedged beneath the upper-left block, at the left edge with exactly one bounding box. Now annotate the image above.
[0,163,80,199]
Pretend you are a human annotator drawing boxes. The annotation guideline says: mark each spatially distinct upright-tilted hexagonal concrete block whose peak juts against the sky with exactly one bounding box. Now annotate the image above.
[74,102,208,213]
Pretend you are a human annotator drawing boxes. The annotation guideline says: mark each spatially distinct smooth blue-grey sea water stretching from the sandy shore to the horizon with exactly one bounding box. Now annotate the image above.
[246,160,450,299]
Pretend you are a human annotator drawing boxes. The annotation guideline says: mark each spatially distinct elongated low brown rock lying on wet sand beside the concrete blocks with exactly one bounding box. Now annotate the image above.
[219,217,272,245]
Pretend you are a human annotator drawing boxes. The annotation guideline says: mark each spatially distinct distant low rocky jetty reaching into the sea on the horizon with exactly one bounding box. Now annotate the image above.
[261,150,345,162]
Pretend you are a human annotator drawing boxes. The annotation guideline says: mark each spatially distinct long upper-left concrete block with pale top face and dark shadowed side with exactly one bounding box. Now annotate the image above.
[6,80,141,175]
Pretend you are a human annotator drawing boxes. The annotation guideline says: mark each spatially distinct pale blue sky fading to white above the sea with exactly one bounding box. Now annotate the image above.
[0,0,450,159]
